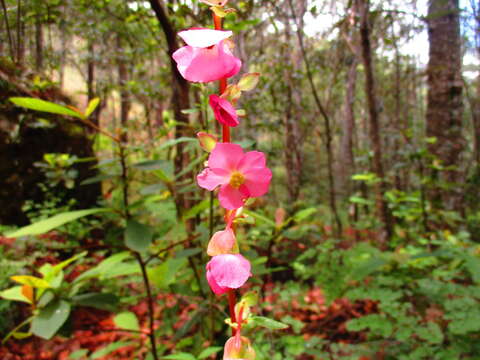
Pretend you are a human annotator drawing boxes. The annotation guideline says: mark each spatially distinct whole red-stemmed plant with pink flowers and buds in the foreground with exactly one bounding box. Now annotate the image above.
[173,0,284,360]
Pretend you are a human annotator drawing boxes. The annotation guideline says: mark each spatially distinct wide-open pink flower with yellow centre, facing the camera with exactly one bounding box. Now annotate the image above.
[197,143,272,210]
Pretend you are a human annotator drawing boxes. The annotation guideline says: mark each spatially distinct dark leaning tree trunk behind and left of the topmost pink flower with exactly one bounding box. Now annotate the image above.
[149,0,192,216]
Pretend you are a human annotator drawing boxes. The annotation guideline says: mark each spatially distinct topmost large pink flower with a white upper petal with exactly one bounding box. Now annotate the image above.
[172,29,242,83]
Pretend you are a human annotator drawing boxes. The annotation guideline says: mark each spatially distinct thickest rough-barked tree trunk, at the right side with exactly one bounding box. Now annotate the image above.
[427,0,465,210]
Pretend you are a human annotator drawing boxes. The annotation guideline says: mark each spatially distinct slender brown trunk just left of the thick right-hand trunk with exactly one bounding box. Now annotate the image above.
[357,0,392,247]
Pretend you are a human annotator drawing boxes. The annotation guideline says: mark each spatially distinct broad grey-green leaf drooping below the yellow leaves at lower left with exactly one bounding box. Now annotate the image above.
[30,300,71,340]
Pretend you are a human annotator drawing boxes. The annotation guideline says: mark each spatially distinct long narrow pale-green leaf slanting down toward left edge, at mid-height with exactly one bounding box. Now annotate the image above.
[6,208,110,238]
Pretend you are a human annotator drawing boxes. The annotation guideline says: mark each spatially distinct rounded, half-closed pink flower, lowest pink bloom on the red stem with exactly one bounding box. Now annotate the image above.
[207,254,252,295]
